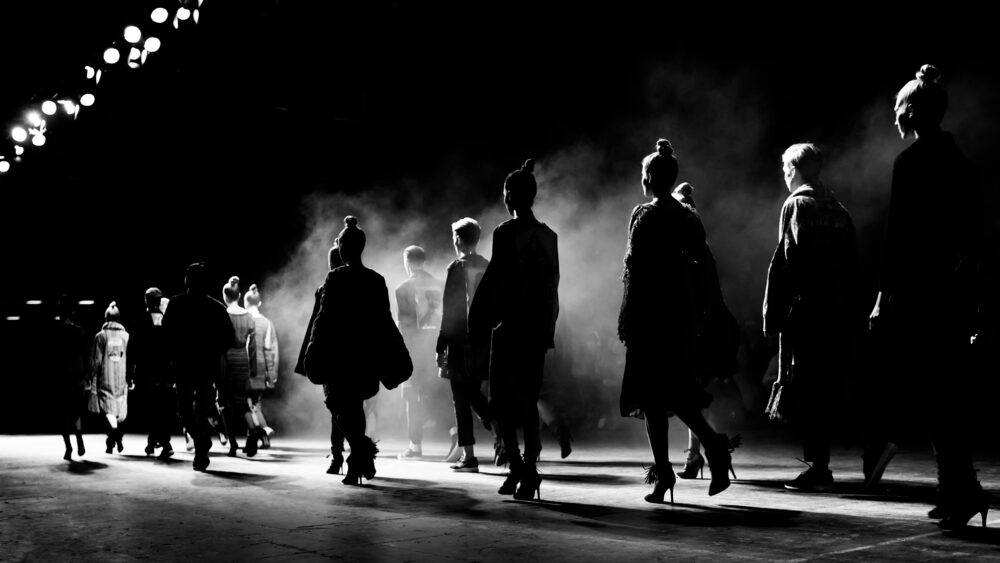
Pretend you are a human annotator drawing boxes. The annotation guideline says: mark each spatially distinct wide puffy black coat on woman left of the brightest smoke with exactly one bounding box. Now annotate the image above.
[304,264,395,402]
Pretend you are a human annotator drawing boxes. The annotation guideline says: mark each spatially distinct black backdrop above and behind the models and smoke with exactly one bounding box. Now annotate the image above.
[0,0,1000,431]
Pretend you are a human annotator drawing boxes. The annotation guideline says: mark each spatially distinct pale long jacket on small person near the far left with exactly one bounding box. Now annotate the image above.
[90,321,129,420]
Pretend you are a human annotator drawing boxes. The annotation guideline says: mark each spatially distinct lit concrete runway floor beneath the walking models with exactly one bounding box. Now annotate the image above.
[0,435,1000,561]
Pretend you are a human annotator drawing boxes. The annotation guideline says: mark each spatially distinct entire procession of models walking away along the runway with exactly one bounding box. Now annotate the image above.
[45,65,989,528]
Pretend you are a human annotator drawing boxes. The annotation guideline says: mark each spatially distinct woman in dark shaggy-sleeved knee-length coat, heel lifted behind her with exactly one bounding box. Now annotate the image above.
[618,139,735,502]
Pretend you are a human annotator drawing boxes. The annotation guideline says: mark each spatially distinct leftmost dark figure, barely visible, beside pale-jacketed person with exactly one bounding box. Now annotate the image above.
[54,295,90,461]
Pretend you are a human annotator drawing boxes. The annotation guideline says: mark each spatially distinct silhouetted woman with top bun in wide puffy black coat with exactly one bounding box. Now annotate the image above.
[304,216,382,485]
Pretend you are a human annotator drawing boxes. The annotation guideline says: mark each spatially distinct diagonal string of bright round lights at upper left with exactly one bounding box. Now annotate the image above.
[0,0,204,176]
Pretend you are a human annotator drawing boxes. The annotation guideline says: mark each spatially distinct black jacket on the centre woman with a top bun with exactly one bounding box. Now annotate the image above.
[469,214,559,350]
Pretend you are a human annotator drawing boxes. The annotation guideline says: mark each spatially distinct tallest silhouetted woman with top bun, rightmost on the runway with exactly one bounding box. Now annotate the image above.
[866,65,989,528]
